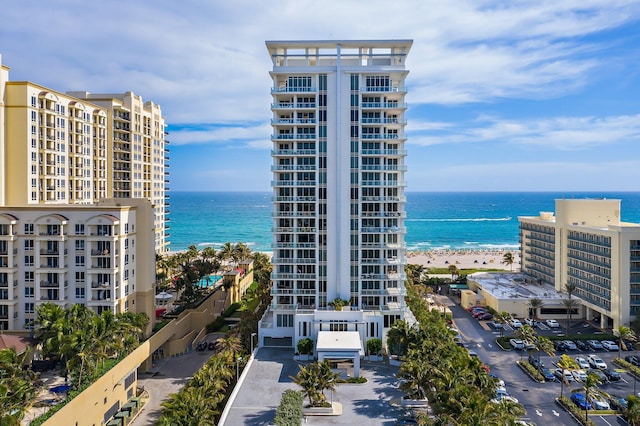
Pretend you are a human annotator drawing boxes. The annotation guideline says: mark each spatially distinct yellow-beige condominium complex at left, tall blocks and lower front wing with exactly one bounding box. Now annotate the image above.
[0,53,168,331]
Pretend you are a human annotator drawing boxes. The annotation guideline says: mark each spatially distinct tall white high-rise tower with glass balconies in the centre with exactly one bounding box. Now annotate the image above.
[259,40,412,354]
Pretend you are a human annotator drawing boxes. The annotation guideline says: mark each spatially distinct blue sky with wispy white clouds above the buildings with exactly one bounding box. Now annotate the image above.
[0,0,640,192]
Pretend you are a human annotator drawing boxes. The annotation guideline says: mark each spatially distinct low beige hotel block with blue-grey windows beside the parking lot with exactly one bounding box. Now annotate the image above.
[518,199,640,329]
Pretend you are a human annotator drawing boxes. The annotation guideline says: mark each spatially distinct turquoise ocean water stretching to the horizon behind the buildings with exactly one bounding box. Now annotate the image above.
[169,191,640,252]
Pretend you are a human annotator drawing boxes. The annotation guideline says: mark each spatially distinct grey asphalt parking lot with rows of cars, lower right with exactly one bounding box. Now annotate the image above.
[443,298,640,425]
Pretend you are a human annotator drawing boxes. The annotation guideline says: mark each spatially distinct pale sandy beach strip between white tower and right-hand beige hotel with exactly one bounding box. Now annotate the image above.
[407,250,520,271]
